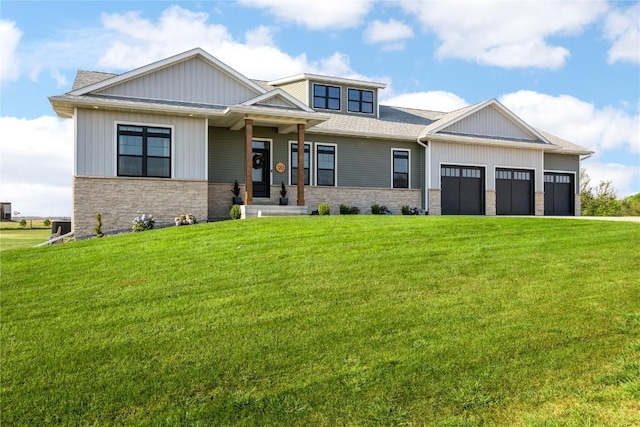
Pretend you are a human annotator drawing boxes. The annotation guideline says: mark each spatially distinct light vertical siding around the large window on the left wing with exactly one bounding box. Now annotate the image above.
[74,109,207,179]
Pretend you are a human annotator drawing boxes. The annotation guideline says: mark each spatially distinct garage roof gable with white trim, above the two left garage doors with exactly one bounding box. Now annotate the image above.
[424,99,550,144]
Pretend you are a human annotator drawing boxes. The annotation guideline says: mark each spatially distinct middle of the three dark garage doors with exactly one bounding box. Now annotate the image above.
[496,169,534,215]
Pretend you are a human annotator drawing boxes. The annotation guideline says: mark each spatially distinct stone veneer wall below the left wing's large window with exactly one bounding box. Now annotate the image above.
[73,176,207,238]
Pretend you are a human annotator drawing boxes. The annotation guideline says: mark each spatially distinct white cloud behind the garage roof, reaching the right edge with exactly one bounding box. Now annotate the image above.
[500,90,640,156]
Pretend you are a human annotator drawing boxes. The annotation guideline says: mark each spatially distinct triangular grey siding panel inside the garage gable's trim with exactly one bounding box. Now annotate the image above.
[443,106,535,141]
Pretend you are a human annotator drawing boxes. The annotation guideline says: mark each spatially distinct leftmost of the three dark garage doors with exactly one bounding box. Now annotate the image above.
[440,166,484,215]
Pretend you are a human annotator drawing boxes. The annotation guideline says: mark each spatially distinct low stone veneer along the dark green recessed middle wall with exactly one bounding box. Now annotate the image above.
[209,184,422,220]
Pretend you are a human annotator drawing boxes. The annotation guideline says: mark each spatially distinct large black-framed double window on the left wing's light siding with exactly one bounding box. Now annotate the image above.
[118,125,171,178]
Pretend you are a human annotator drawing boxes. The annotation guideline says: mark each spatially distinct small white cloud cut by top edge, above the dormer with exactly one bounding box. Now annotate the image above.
[240,0,374,30]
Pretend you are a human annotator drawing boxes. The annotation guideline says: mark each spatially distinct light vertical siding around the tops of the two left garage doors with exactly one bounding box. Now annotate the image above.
[429,141,544,191]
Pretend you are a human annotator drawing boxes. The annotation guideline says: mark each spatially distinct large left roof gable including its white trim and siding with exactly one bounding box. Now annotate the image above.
[70,48,266,105]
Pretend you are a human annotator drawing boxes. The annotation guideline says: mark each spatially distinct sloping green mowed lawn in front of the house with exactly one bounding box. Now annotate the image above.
[0,219,640,426]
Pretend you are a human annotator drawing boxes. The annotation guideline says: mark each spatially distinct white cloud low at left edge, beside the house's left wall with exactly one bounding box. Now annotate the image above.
[0,116,73,216]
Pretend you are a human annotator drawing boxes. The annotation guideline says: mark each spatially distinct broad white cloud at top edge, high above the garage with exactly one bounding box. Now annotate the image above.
[400,0,607,69]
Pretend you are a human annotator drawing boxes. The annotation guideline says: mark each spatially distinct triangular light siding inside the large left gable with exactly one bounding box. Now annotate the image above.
[97,58,260,105]
